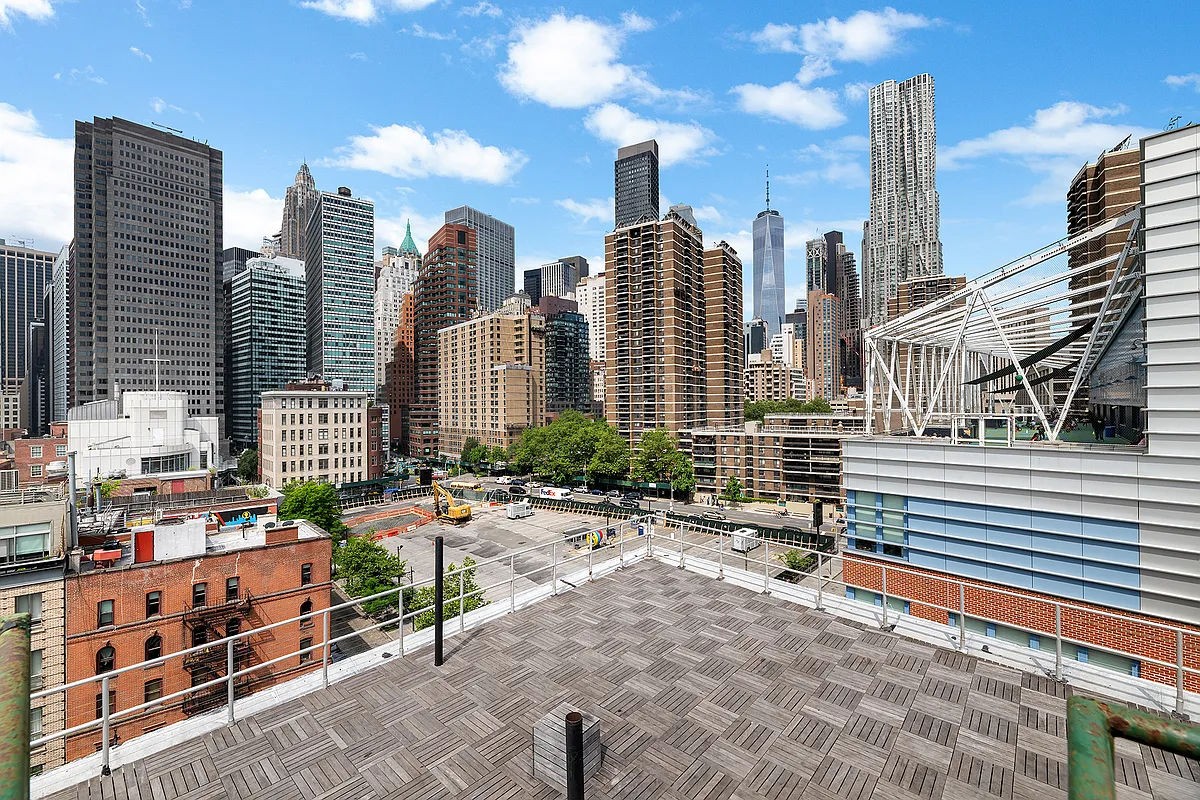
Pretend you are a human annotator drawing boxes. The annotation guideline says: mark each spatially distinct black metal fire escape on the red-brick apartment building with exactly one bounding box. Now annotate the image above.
[182,593,253,714]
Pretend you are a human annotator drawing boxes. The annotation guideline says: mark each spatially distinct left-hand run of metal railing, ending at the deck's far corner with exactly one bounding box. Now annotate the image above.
[26,515,654,775]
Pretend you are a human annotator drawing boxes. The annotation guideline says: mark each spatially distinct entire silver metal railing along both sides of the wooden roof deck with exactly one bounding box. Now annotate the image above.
[30,512,1200,786]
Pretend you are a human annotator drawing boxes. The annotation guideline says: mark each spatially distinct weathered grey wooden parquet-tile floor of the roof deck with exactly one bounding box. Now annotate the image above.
[54,561,1200,800]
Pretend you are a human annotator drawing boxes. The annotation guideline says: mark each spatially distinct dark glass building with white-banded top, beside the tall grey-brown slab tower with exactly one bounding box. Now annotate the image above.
[226,255,306,447]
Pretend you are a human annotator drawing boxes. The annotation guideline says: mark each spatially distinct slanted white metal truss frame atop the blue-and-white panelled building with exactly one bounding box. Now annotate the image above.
[863,205,1142,440]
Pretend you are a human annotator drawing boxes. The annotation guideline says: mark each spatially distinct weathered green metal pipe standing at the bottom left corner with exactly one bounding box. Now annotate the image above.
[0,614,29,800]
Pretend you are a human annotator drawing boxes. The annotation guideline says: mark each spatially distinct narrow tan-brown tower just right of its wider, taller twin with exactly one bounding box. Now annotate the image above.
[704,241,745,425]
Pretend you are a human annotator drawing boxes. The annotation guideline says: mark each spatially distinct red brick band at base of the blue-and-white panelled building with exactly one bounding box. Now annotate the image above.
[842,554,1200,692]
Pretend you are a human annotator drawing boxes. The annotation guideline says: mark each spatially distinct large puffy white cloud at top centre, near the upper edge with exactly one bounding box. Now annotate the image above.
[498,13,701,108]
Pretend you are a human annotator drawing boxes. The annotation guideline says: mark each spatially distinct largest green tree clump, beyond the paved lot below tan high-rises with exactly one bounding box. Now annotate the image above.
[508,410,629,483]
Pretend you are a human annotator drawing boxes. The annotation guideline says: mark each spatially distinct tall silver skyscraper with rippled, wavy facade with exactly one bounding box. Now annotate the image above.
[863,74,942,325]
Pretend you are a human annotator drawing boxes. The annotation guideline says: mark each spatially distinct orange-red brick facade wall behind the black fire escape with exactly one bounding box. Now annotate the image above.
[66,539,332,760]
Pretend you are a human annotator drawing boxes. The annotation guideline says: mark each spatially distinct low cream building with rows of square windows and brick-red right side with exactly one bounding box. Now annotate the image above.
[258,380,386,489]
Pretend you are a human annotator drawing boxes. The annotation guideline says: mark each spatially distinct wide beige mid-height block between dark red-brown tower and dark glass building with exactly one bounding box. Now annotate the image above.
[438,295,546,458]
